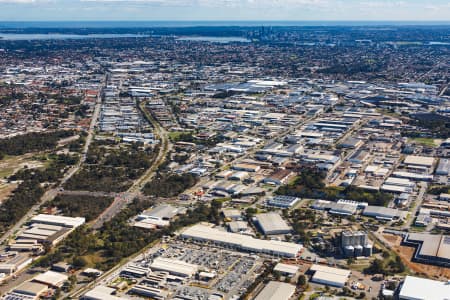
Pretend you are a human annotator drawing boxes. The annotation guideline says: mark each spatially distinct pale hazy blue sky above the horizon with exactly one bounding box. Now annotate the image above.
[0,0,450,21]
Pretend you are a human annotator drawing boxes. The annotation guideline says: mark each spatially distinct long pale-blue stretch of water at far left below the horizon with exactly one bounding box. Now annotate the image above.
[0,33,149,41]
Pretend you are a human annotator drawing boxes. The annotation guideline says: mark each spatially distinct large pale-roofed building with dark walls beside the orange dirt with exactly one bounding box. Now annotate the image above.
[403,233,450,267]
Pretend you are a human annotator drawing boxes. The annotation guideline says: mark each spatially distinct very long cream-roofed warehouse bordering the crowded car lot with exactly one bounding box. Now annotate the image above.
[181,224,303,258]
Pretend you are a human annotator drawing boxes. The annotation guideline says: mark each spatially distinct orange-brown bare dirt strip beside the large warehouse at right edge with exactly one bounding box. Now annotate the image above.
[383,234,450,280]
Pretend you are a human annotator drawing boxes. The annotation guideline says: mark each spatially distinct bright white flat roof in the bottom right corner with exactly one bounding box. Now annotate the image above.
[400,276,450,300]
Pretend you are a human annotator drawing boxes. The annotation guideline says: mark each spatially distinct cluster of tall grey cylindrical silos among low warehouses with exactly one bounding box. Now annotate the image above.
[341,231,373,257]
